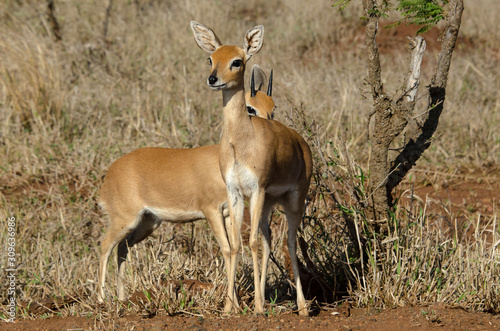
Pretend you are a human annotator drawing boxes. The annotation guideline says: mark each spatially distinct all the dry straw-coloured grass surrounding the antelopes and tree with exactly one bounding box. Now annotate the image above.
[0,0,500,318]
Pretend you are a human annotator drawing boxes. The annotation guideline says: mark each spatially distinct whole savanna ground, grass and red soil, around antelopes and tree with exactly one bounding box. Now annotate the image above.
[0,0,500,330]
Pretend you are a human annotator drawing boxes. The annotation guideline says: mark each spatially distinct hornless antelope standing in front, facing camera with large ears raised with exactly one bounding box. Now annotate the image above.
[191,21,312,315]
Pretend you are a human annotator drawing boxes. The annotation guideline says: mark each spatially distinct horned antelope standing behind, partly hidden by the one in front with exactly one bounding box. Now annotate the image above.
[98,66,274,311]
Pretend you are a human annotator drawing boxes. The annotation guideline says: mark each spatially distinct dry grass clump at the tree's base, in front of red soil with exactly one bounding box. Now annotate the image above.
[352,212,500,313]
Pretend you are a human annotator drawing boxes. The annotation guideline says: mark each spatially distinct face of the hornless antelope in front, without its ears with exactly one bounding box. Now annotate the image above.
[207,46,247,91]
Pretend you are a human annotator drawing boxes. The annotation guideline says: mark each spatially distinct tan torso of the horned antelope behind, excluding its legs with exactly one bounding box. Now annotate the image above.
[100,145,226,217]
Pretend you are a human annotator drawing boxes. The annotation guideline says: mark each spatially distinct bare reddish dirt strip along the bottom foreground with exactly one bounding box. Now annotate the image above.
[1,304,500,331]
